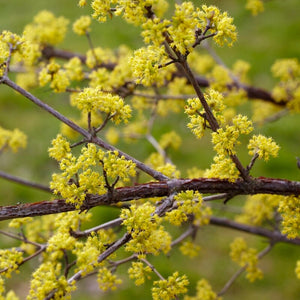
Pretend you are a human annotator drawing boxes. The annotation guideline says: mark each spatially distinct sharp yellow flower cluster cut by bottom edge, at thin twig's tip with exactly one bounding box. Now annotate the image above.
[152,272,189,300]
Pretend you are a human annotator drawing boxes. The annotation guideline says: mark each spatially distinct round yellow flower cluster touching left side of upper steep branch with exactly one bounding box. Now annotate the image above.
[129,46,172,86]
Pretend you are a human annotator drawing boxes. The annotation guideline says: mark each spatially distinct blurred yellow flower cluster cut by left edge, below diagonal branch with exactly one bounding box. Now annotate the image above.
[0,127,27,153]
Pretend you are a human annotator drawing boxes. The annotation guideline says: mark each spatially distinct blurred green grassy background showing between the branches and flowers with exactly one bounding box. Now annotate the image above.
[0,0,300,300]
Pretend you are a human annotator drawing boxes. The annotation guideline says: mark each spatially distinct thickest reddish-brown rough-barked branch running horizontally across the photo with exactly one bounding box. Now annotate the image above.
[0,177,300,221]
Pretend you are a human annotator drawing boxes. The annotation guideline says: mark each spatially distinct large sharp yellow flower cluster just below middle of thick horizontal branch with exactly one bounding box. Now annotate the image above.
[121,203,171,255]
